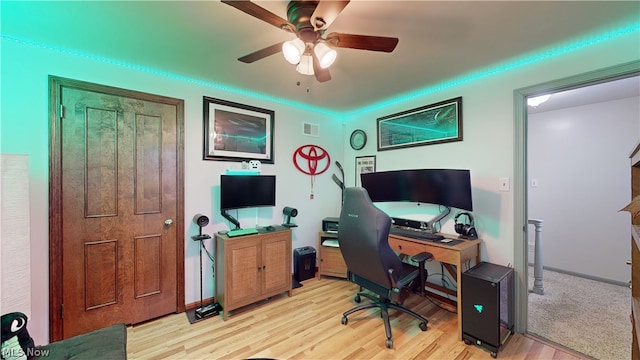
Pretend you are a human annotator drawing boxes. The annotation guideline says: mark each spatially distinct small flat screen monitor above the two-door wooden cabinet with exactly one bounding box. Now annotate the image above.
[220,175,276,210]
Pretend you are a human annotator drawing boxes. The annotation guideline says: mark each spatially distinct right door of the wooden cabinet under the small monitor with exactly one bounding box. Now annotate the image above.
[262,231,291,293]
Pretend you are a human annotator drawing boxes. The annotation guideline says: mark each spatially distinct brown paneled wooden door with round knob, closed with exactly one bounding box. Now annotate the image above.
[50,76,184,338]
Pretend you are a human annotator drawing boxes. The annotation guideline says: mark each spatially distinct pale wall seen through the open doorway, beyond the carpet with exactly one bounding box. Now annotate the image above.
[527,97,640,283]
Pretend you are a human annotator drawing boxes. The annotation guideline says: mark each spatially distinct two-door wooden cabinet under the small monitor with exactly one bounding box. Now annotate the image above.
[215,229,291,320]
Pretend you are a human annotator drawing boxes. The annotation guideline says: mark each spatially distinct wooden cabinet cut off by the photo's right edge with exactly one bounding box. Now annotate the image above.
[630,143,640,360]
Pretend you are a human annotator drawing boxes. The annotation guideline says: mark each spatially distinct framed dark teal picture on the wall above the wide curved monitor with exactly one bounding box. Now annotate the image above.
[378,97,462,151]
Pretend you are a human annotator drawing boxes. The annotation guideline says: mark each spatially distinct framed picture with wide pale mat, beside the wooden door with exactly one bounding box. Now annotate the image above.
[203,96,275,164]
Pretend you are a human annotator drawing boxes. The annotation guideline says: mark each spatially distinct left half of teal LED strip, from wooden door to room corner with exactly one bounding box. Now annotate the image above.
[0,34,341,117]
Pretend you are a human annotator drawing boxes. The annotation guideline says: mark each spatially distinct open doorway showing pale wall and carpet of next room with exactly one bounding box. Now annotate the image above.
[527,77,640,360]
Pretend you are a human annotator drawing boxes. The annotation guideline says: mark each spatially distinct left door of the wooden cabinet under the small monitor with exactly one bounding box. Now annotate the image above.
[225,237,262,308]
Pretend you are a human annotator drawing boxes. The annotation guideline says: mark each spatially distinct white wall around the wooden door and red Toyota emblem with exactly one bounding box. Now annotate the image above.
[0,39,344,344]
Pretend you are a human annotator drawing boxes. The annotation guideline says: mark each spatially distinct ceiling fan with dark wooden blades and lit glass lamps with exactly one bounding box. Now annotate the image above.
[221,0,398,82]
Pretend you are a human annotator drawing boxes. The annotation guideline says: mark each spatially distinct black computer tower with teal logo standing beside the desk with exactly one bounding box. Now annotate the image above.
[461,262,514,358]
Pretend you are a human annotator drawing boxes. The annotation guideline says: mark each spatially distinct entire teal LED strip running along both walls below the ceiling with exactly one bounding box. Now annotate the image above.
[0,23,640,119]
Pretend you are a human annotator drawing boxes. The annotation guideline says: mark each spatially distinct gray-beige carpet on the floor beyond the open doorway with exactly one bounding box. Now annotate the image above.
[528,267,631,360]
